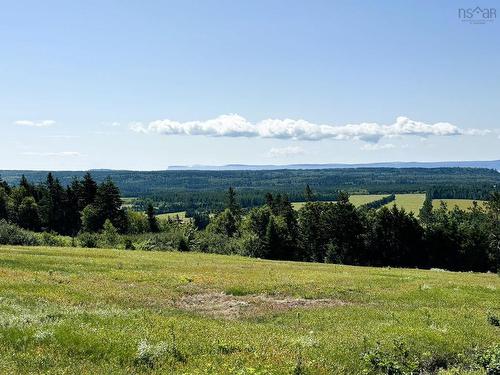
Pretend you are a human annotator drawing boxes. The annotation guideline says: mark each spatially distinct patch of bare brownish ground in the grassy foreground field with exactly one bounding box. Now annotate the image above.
[174,292,348,319]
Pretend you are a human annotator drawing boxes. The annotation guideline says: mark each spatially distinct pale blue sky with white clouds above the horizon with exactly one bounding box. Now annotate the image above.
[0,0,500,170]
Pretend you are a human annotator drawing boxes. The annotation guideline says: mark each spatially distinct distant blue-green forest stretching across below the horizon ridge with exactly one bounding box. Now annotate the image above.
[0,168,500,212]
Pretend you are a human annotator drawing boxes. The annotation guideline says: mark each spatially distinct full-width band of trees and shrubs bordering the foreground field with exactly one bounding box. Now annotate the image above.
[0,173,500,271]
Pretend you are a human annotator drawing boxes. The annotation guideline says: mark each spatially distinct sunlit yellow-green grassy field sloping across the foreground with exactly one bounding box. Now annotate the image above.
[0,246,500,374]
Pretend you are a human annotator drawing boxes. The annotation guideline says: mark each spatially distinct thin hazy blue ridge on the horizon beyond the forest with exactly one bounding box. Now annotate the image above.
[168,160,500,171]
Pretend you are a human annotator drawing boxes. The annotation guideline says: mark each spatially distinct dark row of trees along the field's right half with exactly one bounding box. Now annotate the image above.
[207,190,500,272]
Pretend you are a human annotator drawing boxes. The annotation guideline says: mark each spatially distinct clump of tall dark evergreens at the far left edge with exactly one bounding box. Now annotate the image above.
[0,173,128,236]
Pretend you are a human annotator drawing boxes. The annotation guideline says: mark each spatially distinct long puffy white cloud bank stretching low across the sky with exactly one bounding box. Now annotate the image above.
[130,114,482,143]
